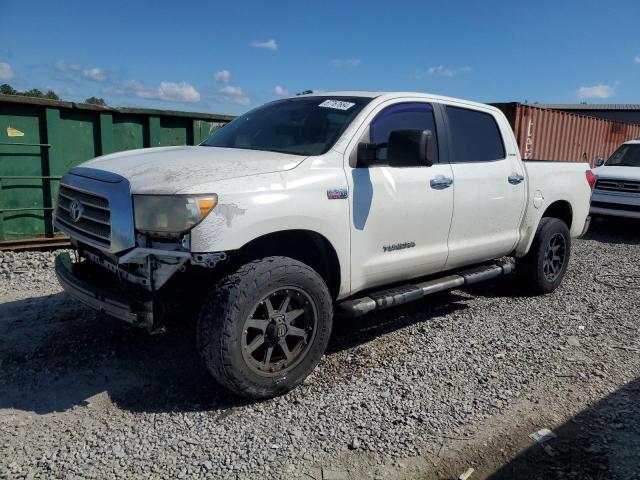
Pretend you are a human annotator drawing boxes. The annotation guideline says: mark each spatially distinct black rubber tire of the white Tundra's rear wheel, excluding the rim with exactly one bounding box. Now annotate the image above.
[516,217,571,295]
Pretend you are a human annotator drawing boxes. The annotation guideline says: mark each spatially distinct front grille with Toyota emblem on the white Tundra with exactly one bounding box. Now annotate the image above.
[56,185,111,247]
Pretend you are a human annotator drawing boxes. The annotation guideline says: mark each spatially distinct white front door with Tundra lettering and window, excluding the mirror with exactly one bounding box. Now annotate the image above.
[347,102,454,292]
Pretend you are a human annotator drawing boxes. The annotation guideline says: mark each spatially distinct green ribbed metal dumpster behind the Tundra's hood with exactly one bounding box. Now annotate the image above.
[0,95,233,249]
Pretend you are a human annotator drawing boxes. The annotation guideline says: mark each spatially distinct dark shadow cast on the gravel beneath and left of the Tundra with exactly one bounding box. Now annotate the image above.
[0,293,466,414]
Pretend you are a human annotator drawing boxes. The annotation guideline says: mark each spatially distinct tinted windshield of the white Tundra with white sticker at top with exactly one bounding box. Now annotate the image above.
[201,96,371,155]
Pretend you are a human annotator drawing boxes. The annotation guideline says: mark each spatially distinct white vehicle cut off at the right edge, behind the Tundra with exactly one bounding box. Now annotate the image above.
[591,140,640,218]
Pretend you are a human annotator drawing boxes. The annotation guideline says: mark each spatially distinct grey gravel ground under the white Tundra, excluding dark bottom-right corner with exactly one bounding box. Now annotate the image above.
[0,218,640,479]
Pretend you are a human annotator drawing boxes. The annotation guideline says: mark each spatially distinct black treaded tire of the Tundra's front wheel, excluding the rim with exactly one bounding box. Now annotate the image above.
[197,257,333,399]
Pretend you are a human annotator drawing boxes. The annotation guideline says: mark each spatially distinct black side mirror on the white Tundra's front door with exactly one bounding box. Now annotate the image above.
[387,130,433,167]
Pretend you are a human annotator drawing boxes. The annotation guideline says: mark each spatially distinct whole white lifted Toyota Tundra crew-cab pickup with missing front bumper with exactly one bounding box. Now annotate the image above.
[55,92,594,398]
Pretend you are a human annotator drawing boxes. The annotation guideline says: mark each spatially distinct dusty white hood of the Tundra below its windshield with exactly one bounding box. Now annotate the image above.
[79,147,305,194]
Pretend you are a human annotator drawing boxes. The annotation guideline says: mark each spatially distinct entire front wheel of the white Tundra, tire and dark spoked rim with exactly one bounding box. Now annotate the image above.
[198,257,333,398]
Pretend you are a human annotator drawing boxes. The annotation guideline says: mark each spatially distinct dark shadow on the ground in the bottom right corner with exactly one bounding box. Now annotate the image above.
[489,379,640,480]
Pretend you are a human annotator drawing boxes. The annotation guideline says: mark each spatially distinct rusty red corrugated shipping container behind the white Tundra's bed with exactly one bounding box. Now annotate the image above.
[492,103,640,166]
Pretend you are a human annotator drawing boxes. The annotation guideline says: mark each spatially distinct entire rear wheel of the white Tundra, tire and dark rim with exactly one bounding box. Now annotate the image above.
[516,217,571,295]
